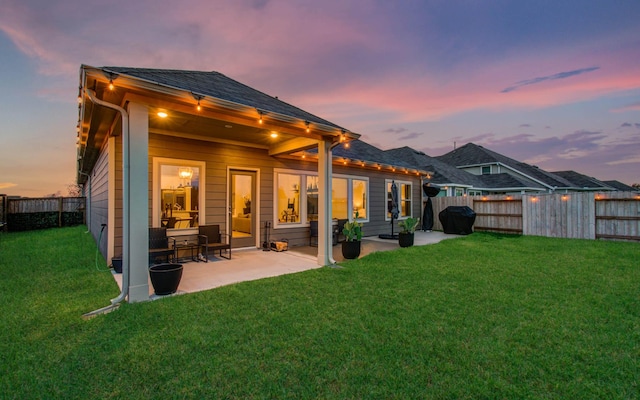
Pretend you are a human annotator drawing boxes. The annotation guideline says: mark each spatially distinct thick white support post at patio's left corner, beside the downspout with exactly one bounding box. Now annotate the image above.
[123,103,149,303]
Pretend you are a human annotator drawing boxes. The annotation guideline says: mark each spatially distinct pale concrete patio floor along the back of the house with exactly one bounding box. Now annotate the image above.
[113,231,459,299]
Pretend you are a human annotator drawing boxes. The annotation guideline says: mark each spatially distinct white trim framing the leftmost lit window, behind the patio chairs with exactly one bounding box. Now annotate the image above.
[151,157,207,235]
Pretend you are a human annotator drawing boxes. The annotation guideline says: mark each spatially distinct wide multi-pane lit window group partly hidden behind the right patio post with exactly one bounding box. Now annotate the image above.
[274,170,369,227]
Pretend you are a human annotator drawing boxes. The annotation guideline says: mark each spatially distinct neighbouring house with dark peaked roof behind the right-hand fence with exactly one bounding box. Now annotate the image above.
[436,143,615,193]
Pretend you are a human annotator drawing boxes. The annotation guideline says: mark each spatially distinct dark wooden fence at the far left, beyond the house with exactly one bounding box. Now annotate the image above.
[6,197,86,231]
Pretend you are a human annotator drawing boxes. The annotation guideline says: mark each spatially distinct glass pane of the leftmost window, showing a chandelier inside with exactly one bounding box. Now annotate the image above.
[160,165,200,229]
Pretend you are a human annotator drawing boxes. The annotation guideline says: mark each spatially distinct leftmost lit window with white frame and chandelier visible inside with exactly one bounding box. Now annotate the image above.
[152,158,205,230]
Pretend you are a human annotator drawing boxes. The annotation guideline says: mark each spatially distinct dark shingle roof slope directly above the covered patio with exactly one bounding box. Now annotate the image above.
[103,67,343,129]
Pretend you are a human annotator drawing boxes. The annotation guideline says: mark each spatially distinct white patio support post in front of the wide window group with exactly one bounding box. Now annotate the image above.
[318,141,333,266]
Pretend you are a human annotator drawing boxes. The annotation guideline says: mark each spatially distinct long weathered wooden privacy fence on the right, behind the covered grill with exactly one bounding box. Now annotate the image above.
[431,192,640,241]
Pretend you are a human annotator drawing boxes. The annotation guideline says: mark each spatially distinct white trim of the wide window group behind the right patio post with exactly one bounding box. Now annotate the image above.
[273,168,371,229]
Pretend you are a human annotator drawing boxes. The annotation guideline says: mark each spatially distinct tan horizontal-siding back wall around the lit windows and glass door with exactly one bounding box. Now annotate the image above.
[105,133,423,255]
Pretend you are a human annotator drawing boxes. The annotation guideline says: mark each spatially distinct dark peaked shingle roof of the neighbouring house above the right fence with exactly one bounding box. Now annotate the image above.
[437,143,573,189]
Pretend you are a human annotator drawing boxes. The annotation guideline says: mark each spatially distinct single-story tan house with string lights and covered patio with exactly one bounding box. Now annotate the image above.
[77,65,431,302]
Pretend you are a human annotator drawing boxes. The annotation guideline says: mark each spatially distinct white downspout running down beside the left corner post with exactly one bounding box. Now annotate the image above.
[84,89,130,316]
